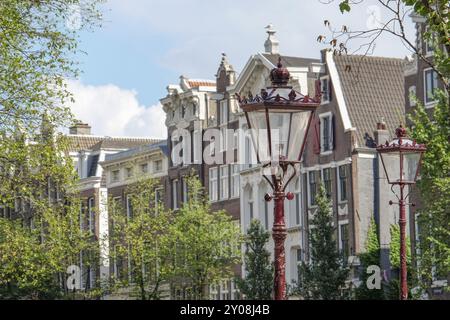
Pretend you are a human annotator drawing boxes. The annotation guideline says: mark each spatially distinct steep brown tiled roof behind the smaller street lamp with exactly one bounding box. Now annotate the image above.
[333,55,405,147]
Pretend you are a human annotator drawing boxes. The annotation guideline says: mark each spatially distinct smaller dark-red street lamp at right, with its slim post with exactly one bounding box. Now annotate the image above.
[377,126,426,300]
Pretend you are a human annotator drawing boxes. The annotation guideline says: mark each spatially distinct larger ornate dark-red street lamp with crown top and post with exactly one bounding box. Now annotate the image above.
[237,58,320,300]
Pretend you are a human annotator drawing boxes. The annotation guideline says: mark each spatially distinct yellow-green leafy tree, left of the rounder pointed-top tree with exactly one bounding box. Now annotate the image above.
[108,178,173,300]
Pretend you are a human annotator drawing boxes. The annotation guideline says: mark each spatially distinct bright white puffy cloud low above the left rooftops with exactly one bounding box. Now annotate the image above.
[68,80,167,138]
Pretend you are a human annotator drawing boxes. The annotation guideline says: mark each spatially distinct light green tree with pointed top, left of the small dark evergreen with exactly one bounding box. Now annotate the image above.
[169,175,241,299]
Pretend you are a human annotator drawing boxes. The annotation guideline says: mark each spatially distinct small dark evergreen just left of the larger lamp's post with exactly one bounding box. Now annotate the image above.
[236,220,274,300]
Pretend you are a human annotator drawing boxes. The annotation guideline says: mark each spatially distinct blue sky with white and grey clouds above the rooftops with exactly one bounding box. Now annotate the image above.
[70,0,414,137]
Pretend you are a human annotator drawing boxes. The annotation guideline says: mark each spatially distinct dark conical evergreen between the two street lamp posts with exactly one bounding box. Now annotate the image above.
[296,185,349,300]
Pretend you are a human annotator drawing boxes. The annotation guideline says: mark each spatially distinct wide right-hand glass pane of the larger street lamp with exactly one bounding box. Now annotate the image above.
[269,109,312,161]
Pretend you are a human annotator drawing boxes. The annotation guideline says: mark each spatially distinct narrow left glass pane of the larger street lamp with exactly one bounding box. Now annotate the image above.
[246,109,270,162]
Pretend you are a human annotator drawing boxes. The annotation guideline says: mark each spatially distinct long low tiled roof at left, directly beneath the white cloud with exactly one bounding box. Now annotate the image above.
[67,134,161,151]
